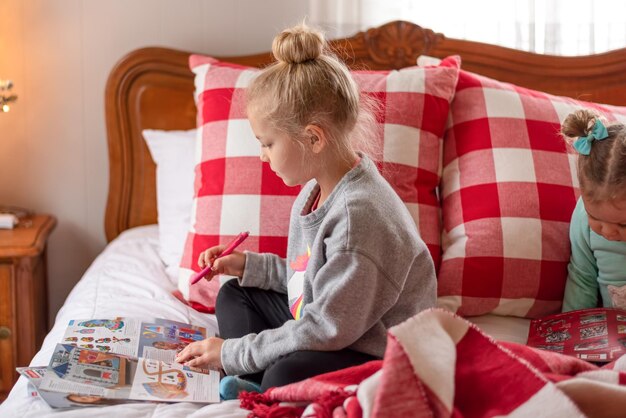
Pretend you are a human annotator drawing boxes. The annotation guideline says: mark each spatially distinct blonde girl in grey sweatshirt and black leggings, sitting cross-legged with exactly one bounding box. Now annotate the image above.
[173,25,436,399]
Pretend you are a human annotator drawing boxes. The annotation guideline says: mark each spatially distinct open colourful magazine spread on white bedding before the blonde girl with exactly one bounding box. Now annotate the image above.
[18,317,219,408]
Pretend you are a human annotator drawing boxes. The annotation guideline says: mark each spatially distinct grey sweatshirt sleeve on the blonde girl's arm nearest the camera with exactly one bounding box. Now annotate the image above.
[222,250,406,375]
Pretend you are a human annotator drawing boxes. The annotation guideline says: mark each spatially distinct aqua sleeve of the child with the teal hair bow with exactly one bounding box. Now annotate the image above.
[563,199,598,312]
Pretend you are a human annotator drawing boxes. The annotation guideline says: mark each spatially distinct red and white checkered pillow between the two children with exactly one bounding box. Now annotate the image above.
[438,71,626,318]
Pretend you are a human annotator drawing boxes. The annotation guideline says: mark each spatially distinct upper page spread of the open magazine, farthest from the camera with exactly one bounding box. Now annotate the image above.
[62,317,208,362]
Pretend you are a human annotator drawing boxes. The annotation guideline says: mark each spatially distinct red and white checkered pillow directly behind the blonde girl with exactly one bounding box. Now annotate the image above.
[178,55,460,309]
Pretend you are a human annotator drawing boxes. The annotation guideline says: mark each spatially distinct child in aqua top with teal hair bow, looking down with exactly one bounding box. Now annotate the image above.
[561,110,626,312]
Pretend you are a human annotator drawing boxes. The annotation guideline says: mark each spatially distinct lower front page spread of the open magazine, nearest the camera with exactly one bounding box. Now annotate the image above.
[40,344,219,403]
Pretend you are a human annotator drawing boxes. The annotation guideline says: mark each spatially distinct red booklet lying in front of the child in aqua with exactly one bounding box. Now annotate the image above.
[527,308,626,362]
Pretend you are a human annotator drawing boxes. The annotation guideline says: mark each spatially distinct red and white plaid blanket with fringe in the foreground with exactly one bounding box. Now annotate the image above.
[241,309,626,418]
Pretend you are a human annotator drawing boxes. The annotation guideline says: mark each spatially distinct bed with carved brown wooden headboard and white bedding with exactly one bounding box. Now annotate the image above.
[0,21,626,417]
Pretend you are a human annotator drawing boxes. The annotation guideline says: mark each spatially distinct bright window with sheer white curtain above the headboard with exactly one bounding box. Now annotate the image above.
[309,0,626,55]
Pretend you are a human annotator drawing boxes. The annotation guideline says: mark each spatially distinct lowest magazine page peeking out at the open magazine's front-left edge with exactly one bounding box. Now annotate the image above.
[16,366,127,408]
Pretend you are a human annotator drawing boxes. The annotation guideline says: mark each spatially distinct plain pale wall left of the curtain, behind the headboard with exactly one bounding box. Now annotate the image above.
[0,0,307,320]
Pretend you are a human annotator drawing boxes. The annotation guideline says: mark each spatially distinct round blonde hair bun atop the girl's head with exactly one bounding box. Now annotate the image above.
[272,24,326,64]
